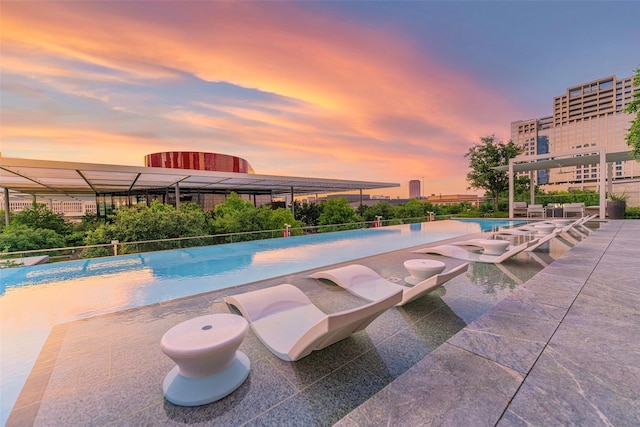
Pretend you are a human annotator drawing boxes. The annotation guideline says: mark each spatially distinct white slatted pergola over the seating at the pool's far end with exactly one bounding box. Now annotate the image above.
[494,147,633,218]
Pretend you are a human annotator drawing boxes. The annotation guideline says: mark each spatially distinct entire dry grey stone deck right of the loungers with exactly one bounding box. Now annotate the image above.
[337,221,640,426]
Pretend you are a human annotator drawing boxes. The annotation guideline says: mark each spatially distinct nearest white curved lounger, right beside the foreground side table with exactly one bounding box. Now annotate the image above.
[225,284,402,361]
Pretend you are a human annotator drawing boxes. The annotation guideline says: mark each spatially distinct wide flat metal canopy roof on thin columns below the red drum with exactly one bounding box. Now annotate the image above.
[0,157,400,200]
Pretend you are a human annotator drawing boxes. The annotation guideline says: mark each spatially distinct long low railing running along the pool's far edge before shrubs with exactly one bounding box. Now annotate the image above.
[0,215,444,268]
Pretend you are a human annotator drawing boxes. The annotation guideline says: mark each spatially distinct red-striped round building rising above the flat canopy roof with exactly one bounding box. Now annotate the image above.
[144,151,255,173]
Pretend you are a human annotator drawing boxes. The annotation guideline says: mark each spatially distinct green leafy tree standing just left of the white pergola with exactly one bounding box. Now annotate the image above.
[464,135,523,211]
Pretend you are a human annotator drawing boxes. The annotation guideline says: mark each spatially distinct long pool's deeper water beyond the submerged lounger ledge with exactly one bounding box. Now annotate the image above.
[0,220,522,424]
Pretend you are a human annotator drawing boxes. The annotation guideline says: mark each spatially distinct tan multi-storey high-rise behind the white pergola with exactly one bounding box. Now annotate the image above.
[511,76,640,196]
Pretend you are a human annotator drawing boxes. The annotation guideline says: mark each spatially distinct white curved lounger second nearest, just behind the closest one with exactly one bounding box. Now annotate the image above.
[309,263,469,306]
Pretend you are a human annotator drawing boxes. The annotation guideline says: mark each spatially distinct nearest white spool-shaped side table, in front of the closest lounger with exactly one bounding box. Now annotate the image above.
[160,313,251,406]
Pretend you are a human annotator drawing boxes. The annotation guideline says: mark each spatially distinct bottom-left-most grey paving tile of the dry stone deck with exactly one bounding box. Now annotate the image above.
[336,344,523,426]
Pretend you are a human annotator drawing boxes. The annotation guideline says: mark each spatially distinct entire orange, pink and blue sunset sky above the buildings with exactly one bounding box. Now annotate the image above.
[0,0,640,197]
